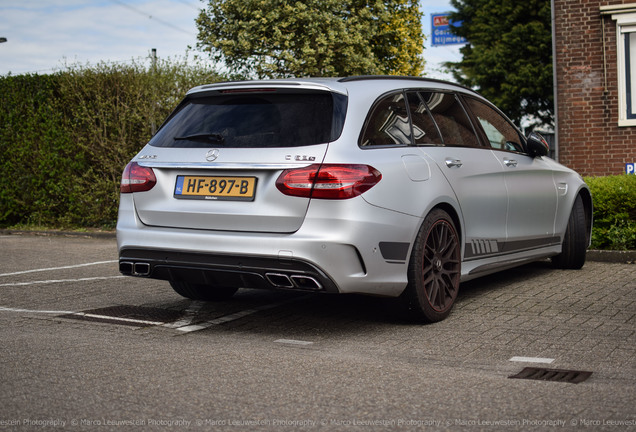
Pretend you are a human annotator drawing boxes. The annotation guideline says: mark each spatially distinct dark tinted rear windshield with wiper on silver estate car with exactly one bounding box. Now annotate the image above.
[150,90,347,148]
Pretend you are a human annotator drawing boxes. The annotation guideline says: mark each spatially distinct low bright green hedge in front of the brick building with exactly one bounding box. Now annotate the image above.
[585,175,636,250]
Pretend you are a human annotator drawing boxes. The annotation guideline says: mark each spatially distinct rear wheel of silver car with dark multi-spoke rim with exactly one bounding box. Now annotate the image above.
[402,209,461,323]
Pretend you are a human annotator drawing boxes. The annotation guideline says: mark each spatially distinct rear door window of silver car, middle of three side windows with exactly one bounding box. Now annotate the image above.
[420,92,479,147]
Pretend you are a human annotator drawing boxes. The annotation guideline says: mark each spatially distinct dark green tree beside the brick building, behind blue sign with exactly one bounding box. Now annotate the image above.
[447,0,554,125]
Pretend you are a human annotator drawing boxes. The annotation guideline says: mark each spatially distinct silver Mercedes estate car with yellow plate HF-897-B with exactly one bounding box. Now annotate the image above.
[117,77,592,322]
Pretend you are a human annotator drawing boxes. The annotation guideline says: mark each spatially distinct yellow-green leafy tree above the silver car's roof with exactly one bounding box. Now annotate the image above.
[196,0,424,78]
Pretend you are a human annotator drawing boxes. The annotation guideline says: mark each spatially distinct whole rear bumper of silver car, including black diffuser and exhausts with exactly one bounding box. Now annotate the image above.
[117,194,420,297]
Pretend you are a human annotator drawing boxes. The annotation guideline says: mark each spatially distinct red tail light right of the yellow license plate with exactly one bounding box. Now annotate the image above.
[276,164,382,199]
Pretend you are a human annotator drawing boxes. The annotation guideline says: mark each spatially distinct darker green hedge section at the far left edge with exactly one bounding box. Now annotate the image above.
[0,74,75,228]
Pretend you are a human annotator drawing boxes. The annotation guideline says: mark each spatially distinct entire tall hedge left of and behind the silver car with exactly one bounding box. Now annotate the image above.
[0,61,225,228]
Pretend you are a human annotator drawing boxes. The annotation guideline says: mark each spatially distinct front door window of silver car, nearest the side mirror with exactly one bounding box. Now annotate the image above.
[465,97,524,153]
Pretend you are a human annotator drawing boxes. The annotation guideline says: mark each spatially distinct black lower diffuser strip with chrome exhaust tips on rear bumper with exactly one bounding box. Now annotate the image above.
[119,248,338,293]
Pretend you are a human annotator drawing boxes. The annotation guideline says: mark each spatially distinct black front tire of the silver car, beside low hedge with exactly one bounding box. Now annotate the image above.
[552,195,588,270]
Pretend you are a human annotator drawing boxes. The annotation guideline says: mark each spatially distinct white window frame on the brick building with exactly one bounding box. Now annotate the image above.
[612,9,636,127]
